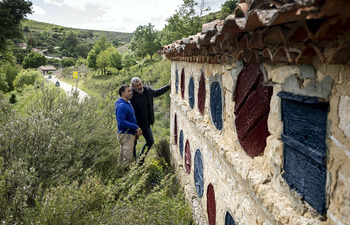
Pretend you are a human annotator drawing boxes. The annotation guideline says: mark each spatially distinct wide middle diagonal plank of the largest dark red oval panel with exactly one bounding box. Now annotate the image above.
[235,84,272,140]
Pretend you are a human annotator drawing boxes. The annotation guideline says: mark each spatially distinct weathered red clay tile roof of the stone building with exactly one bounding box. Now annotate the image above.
[159,0,350,64]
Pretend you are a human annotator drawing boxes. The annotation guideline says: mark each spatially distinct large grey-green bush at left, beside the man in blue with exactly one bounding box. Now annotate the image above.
[0,90,123,224]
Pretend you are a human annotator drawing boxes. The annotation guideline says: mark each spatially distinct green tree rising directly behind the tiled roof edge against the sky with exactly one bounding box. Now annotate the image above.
[160,0,210,45]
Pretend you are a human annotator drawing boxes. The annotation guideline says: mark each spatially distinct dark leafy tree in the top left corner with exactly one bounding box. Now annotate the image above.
[0,0,32,54]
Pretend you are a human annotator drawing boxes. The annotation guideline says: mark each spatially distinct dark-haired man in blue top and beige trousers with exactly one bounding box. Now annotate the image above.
[115,85,142,166]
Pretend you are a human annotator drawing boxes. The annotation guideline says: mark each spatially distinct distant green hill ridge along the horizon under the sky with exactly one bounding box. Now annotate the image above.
[22,20,133,45]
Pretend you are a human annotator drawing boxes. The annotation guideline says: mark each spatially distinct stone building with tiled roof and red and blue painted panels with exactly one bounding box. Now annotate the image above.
[160,0,350,225]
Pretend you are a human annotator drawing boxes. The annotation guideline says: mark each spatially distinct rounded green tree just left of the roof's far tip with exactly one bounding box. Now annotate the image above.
[129,23,160,60]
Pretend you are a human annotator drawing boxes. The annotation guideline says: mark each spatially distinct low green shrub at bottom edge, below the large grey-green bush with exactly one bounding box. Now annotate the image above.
[33,177,114,224]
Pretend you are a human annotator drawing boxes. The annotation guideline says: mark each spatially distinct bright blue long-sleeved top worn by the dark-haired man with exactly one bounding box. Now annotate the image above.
[115,98,138,134]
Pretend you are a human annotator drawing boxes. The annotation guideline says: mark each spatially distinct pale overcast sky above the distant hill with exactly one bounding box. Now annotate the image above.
[27,0,225,32]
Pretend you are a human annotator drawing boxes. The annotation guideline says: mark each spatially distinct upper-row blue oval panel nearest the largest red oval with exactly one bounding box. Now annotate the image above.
[210,82,222,130]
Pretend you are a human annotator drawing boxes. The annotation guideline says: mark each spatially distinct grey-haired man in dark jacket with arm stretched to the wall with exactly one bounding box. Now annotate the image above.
[130,77,171,163]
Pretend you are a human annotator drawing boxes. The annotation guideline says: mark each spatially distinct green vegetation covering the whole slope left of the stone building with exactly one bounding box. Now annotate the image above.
[0,0,236,224]
